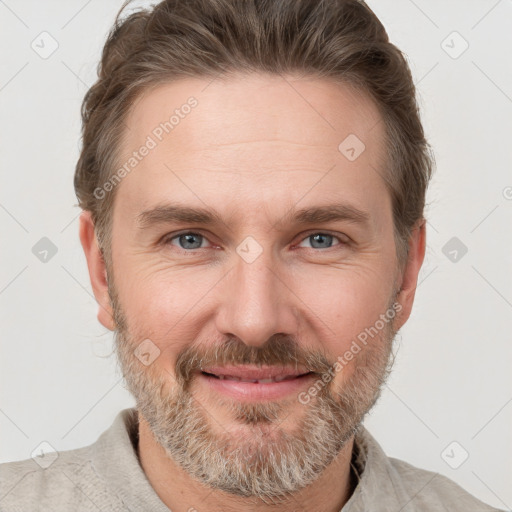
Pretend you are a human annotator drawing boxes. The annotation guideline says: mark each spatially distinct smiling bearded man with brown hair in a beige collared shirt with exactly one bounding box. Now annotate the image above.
[0,0,502,512]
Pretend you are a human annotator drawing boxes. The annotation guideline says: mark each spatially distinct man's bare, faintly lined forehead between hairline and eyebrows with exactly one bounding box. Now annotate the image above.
[116,74,389,228]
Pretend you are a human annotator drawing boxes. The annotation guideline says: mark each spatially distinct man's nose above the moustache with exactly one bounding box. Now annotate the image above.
[216,251,299,346]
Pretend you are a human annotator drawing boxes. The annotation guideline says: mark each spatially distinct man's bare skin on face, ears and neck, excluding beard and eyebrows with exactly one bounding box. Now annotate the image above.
[80,74,426,512]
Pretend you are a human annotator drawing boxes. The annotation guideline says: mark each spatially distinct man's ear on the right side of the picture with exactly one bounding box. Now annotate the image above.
[393,219,427,331]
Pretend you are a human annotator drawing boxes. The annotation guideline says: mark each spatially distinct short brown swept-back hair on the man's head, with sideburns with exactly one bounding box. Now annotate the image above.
[74,0,434,272]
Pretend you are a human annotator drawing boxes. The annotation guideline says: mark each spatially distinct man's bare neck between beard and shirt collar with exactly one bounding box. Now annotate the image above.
[138,414,357,512]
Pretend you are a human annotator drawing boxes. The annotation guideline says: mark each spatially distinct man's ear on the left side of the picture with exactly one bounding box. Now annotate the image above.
[79,211,115,331]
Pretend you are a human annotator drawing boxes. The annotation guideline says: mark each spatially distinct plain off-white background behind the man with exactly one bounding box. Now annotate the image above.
[0,0,512,510]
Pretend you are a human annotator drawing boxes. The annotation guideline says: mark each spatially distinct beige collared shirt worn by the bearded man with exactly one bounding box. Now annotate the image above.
[0,408,504,512]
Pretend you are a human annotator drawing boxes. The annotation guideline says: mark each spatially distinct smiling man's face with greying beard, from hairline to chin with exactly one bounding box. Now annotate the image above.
[109,75,406,497]
